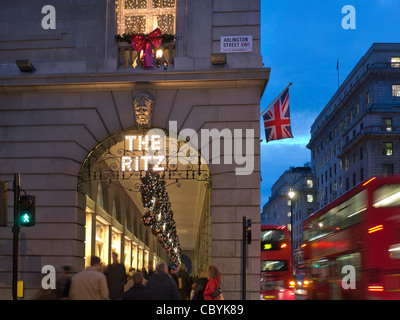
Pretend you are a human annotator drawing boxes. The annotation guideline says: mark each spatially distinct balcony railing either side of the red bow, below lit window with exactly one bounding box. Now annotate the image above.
[118,41,175,70]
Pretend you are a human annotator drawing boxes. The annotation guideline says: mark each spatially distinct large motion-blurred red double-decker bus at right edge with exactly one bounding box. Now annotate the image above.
[303,176,400,299]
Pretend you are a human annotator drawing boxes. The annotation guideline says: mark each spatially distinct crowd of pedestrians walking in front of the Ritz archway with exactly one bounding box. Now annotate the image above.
[33,252,223,300]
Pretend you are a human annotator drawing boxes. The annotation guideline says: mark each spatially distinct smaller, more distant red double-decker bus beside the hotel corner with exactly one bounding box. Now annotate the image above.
[260,225,295,300]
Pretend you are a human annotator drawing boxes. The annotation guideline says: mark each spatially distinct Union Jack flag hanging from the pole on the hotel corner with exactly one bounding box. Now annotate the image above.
[263,88,293,142]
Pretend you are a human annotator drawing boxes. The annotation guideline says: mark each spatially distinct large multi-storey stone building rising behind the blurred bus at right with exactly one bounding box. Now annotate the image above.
[307,43,400,206]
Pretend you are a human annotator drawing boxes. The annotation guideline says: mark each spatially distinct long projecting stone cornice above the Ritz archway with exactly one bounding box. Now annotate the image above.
[0,68,271,95]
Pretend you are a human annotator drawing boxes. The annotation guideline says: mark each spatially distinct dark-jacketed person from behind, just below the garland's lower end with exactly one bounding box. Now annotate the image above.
[147,262,180,300]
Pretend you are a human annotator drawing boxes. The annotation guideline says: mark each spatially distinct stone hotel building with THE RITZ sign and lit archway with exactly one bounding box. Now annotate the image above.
[0,0,270,299]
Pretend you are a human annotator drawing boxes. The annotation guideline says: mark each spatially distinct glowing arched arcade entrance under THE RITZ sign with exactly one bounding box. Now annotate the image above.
[78,128,211,272]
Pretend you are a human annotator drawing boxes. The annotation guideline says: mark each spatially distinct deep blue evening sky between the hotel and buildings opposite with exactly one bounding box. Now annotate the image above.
[260,0,400,206]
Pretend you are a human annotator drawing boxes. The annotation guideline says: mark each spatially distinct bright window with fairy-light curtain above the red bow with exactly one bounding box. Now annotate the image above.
[117,0,176,34]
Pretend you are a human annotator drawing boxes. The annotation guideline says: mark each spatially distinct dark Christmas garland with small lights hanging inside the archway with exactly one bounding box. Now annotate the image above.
[140,171,181,264]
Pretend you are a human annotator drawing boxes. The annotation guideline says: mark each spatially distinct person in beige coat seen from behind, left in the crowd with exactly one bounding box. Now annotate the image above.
[69,256,109,300]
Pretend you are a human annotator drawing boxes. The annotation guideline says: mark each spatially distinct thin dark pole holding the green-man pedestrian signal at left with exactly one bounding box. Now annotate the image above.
[12,173,21,300]
